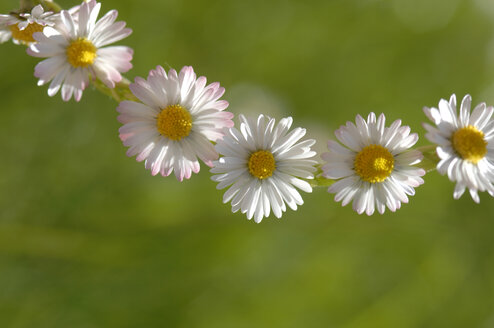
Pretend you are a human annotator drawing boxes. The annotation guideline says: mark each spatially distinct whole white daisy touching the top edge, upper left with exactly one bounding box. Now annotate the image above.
[28,0,133,101]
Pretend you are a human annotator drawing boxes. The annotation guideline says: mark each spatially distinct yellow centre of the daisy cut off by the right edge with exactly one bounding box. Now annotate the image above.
[451,125,487,164]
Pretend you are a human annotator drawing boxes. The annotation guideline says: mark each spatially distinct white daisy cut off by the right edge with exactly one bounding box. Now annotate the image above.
[424,95,494,203]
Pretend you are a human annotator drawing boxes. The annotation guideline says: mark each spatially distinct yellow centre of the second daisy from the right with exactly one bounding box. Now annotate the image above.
[354,145,395,183]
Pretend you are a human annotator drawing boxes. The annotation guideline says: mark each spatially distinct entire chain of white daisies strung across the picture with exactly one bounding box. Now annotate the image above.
[0,0,494,222]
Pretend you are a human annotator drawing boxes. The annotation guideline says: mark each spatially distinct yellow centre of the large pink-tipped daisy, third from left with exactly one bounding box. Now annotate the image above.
[156,105,192,140]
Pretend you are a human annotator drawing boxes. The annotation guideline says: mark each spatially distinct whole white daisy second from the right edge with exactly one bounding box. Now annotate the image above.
[321,113,425,215]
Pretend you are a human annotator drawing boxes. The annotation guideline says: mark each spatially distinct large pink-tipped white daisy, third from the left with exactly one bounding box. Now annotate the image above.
[117,66,233,181]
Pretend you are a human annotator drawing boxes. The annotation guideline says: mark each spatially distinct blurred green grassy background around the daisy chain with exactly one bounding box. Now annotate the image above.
[0,0,494,328]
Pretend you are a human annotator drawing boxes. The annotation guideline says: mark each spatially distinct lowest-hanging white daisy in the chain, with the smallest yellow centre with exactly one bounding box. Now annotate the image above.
[211,115,316,223]
